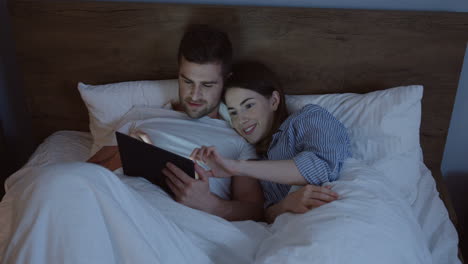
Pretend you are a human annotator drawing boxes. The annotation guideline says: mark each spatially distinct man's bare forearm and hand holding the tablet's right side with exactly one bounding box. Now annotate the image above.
[163,163,263,221]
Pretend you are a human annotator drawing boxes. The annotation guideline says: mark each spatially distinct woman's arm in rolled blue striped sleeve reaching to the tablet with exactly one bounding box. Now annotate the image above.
[191,105,350,185]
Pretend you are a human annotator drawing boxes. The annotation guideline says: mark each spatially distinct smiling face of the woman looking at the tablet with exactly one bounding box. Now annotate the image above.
[225,87,279,144]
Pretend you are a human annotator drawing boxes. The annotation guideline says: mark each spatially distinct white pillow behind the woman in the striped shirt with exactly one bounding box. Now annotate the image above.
[286,85,423,204]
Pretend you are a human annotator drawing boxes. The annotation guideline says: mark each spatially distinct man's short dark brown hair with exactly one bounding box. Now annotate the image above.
[178,25,232,79]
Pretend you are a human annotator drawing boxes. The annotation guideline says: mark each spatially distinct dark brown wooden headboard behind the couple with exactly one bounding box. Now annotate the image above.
[9,0,468,254]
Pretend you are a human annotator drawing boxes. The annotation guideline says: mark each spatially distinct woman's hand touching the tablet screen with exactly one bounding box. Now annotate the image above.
[190,146,238,178]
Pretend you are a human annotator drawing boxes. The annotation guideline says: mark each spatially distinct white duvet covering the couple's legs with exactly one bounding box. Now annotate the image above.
[0,156,433,264]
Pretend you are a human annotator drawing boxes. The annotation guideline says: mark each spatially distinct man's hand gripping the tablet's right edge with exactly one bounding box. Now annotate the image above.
[162,162,218,213]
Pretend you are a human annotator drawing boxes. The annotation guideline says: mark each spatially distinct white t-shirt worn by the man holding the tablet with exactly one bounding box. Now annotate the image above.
[112,106,257,199]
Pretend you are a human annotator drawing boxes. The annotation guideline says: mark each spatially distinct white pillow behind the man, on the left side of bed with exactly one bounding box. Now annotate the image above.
[78,79,179,154]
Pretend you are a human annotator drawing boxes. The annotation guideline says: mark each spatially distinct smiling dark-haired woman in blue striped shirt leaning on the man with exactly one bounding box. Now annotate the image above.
[191,62,350,222]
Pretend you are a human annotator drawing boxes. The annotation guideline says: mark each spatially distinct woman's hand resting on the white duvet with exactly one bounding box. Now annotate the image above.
[281,185,339,214]
